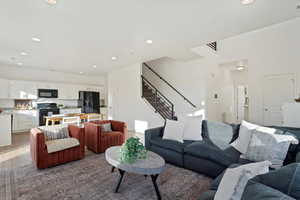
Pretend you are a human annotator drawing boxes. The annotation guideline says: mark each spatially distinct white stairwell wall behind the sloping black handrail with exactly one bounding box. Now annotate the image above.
[144,58,218,120]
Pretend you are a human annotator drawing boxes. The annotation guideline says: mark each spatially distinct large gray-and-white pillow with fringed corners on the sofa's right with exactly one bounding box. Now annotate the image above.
[243,127,298,168]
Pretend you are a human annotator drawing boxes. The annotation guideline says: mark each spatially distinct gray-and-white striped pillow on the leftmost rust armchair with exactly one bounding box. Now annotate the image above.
[39,125,70,140]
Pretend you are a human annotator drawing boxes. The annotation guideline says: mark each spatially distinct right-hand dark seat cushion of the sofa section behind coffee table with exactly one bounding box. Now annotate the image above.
[184,141,237,166]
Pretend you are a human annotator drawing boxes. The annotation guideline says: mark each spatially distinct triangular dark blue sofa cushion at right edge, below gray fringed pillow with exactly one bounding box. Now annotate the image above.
[247,163,300,199]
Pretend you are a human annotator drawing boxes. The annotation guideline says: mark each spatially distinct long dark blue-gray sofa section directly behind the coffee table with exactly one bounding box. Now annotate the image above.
[145,120,248,178]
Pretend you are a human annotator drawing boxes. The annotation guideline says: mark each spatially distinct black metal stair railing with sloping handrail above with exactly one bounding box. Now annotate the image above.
[141,63,196,120]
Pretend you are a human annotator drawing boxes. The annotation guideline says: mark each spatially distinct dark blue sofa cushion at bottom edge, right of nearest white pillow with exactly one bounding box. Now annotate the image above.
[241,180,295,200]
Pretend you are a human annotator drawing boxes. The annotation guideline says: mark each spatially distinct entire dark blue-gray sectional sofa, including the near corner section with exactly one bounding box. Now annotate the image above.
[145,120,300,200]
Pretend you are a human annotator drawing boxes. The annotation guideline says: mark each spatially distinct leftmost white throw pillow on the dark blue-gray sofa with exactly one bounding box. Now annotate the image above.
[163,119,184,143]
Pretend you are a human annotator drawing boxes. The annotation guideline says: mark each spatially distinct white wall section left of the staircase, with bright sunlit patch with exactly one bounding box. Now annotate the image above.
[108,64,164,132]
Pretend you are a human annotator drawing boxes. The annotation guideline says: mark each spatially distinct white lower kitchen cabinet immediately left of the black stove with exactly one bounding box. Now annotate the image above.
[13,110,39,133]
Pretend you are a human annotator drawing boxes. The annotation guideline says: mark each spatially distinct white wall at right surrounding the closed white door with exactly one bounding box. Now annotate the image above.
[219,18,300,124]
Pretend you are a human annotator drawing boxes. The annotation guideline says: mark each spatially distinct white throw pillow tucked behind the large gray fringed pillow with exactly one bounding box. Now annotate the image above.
[231,121,260,154]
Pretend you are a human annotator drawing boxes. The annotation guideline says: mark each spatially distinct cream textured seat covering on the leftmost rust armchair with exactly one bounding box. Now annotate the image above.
[46,138,80,153]
